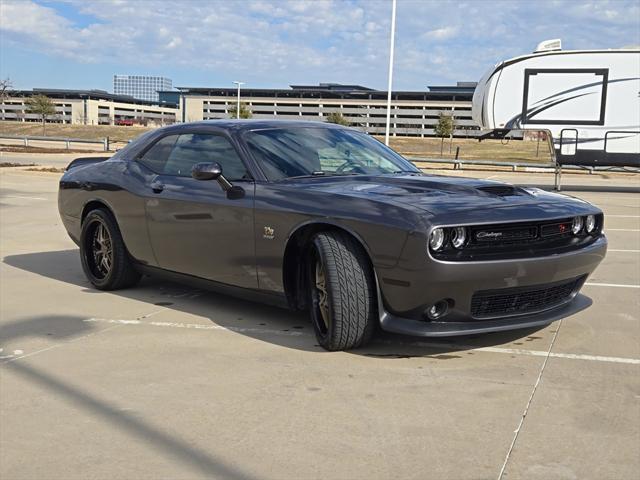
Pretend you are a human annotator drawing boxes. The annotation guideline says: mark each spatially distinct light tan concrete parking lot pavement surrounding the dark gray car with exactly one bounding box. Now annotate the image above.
[0,166,640,480]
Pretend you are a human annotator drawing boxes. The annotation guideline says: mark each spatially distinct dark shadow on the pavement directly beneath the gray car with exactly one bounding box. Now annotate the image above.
[4,249,544,359]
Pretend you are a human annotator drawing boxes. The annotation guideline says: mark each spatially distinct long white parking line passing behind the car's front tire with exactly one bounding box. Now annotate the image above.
[84,318,640,365]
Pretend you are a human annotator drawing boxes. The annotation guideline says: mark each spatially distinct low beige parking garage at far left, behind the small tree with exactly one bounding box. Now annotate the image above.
[0,88,178,126]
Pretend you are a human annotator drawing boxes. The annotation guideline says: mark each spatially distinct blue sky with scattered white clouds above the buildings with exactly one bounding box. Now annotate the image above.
[0,0,640,91]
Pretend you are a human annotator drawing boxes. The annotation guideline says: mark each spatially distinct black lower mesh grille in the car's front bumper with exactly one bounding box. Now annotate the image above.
[471,277,585,318]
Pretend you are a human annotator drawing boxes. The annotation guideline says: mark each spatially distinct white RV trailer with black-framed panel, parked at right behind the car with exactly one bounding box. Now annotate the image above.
[472,40,640,167]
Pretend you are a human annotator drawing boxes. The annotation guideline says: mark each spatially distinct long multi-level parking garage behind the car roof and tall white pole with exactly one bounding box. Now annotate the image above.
[160,82,479,137]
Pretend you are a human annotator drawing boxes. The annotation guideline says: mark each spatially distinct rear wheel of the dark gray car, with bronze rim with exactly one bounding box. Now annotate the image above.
[80,209,141,290]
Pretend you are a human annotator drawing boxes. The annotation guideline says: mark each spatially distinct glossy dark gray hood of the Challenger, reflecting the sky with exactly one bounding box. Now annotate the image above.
[284,175,582,215]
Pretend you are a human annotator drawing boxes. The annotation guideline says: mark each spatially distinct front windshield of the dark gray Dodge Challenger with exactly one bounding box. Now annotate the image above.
[245,127,421,181]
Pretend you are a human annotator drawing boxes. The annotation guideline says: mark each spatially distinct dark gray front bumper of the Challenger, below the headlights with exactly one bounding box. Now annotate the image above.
[376,235,607,336]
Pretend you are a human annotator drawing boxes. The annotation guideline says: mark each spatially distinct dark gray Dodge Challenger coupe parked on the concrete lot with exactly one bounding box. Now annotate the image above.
[58,120,607,350]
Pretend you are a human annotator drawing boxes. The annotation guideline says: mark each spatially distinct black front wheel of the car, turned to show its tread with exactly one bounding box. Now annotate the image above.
[308,231,378,351]
